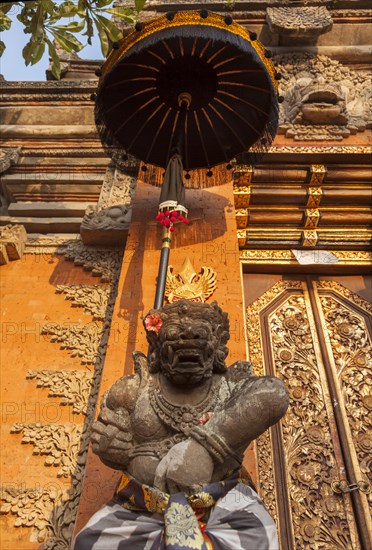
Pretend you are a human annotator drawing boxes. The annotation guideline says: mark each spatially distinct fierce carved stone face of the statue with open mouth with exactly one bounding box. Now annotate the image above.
[158,316,215,386]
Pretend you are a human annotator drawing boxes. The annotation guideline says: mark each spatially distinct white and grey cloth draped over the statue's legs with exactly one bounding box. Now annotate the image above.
[72,483,279,550]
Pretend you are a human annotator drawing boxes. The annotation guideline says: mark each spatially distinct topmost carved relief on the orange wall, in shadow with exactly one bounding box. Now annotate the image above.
[56,239,121,283]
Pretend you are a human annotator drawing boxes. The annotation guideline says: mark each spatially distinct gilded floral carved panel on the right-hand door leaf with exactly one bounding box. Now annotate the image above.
[318,283,372,481]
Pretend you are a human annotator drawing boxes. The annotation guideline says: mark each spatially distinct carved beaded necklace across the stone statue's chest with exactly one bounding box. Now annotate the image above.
[149,376,220,436]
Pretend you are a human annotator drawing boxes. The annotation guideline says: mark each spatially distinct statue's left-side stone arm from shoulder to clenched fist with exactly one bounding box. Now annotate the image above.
[91,356,145,470]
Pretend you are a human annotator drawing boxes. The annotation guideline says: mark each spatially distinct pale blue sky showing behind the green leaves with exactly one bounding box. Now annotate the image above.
[0,6,103,80]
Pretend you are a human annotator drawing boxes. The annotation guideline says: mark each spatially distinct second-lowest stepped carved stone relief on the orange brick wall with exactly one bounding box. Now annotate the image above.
[11,423,83,477]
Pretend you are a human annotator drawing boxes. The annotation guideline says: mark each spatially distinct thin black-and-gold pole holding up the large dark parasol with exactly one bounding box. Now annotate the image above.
[154,96,192,309]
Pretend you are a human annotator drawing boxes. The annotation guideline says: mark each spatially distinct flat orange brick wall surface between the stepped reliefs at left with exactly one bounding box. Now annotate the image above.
[0,255,110,550]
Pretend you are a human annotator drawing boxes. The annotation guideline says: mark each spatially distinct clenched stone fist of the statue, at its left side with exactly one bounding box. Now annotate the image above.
[91,407,133,469]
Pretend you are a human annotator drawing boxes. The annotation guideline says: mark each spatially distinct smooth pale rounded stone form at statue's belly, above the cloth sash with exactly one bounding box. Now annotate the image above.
[154,439,214,495]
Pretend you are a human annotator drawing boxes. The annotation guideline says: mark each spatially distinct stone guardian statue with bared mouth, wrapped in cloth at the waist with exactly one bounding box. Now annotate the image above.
[73,300,288,550]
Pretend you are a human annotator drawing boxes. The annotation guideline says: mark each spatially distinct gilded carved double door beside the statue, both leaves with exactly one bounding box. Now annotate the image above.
[245,275,372,550]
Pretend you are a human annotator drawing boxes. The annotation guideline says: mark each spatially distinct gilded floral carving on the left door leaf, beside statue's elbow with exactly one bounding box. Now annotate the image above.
[247,281,357,550]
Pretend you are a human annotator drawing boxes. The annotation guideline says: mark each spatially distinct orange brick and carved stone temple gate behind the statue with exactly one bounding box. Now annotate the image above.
[0,0,372,550]
